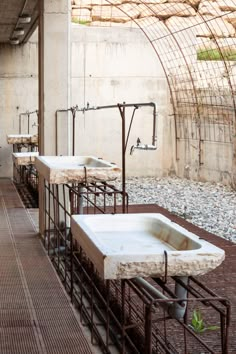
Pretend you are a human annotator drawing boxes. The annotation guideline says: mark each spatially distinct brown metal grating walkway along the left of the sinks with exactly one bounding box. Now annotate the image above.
[0,179,92,354]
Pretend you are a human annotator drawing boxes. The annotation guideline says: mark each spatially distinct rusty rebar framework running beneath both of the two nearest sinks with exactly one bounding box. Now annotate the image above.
[41,182,230,354]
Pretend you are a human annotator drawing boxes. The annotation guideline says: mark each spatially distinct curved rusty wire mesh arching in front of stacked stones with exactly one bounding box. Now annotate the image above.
[72,0,236,164]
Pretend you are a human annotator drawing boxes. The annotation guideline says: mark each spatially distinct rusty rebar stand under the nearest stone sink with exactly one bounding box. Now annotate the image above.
[70,248,230,354]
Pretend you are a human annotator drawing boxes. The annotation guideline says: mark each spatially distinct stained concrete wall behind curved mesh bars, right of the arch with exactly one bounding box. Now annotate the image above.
[172,61,236,184]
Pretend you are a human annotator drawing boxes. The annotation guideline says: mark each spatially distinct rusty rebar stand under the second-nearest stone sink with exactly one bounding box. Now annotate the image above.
[44,181,128,292]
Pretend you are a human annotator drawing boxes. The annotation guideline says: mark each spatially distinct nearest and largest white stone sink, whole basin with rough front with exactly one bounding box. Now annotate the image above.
[71,214,225,279]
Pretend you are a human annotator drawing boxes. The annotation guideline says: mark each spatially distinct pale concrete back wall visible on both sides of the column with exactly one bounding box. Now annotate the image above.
[0,27,173,176]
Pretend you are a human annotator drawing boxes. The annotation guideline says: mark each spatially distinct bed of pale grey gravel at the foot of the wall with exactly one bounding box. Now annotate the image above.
[119,177,236,242]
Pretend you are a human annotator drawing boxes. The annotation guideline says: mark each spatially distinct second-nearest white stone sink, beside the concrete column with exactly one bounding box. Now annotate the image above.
[35,156,121,184]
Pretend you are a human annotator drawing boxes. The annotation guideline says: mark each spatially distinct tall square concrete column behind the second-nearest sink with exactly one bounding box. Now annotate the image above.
[39,0,71,234]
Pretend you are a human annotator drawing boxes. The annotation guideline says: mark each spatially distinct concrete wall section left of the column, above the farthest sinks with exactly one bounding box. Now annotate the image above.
[0,32,38,177]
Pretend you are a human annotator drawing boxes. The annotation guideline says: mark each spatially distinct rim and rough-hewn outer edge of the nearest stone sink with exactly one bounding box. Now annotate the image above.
[71,213,224,279]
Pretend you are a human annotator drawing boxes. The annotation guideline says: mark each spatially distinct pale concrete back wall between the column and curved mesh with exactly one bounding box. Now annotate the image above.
[66,26,173,176]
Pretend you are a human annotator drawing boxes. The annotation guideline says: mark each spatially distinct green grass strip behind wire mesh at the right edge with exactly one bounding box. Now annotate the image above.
[197,48,236,61]
